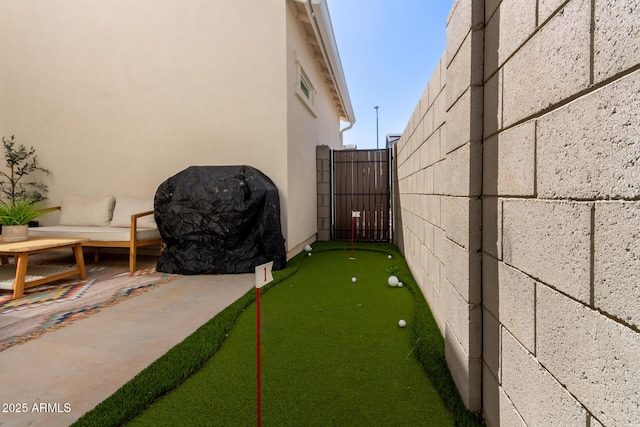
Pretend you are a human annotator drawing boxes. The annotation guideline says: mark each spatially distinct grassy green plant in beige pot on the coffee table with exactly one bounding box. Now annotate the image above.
[0,199,53,243]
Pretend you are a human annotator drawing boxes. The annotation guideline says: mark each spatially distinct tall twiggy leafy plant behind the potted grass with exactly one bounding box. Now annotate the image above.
[0,135,51,203]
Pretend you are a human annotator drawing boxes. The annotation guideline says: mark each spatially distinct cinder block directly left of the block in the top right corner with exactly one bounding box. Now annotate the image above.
[503,0,591,126]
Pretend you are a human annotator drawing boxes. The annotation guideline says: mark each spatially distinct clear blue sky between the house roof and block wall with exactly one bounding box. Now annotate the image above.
[327,0,453,149]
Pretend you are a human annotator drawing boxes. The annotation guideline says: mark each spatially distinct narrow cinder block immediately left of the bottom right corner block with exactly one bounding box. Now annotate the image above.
[498,262,536,353]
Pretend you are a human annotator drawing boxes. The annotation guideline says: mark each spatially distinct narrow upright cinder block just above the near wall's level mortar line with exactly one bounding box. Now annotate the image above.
[496,121,536,196]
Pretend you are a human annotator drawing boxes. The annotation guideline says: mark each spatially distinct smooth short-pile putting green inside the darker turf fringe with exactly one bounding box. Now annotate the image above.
[130,250,453,426]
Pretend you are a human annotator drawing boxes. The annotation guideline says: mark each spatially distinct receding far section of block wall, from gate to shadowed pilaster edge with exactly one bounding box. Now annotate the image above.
[395,1,484,411]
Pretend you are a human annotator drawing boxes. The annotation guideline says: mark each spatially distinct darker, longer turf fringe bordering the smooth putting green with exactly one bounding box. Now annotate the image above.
[73,242,483,427]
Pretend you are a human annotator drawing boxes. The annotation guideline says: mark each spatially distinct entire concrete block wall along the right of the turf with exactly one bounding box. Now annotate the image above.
[395,0,640,426]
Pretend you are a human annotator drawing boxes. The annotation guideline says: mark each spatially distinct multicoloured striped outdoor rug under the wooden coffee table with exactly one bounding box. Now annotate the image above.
[0,253,178,351]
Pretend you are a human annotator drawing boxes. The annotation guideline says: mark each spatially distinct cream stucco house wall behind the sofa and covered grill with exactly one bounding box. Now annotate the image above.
[0,0,288,229]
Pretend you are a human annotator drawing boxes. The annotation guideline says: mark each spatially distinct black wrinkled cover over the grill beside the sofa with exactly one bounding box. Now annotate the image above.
[154,166,286,274]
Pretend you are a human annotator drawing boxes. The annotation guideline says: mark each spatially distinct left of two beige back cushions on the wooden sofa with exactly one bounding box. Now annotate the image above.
[59,196,114,227]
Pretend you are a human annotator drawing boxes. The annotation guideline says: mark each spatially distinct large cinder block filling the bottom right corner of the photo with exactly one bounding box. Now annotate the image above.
[536,285,640,426]
